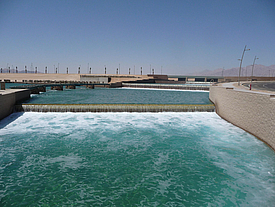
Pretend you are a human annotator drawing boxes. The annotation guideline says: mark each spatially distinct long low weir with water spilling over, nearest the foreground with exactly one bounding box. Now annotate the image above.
[15,104,215,112]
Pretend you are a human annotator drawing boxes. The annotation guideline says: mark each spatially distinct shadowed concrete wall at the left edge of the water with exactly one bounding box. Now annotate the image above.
[0,89,30,120]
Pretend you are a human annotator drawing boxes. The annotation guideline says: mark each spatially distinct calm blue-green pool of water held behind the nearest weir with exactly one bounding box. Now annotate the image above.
[22,87,211,104]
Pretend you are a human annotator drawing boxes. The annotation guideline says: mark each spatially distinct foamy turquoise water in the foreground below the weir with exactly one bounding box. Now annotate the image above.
[0,113,275,206]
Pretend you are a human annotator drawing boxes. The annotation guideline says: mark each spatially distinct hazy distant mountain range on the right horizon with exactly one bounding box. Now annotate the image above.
[189,65,275,77]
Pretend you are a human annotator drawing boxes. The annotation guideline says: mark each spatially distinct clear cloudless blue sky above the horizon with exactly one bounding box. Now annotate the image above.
[0,0,275,75]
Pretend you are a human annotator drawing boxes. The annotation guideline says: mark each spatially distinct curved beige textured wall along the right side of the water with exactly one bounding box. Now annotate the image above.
[209,86,275,150]
